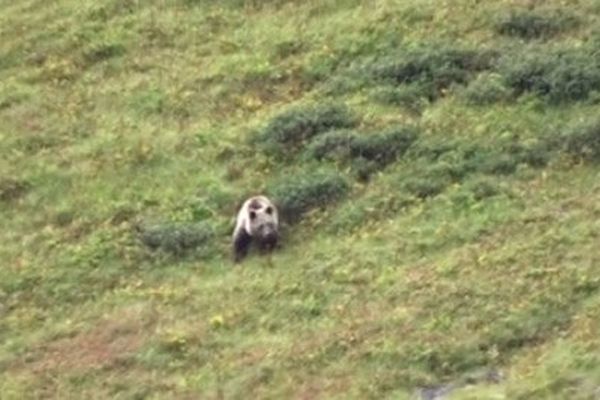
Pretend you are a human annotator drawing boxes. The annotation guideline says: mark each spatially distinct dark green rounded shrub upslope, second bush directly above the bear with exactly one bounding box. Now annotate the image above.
[257,104,356,154]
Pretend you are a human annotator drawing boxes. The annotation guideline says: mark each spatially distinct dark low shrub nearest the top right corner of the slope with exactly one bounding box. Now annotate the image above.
[494,10,577,39]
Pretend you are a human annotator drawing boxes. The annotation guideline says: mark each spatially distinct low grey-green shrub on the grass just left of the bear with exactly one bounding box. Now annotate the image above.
[136,223,213,255]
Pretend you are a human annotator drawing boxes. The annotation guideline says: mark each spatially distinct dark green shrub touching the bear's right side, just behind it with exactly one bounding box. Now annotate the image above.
[268,171,350,223]
